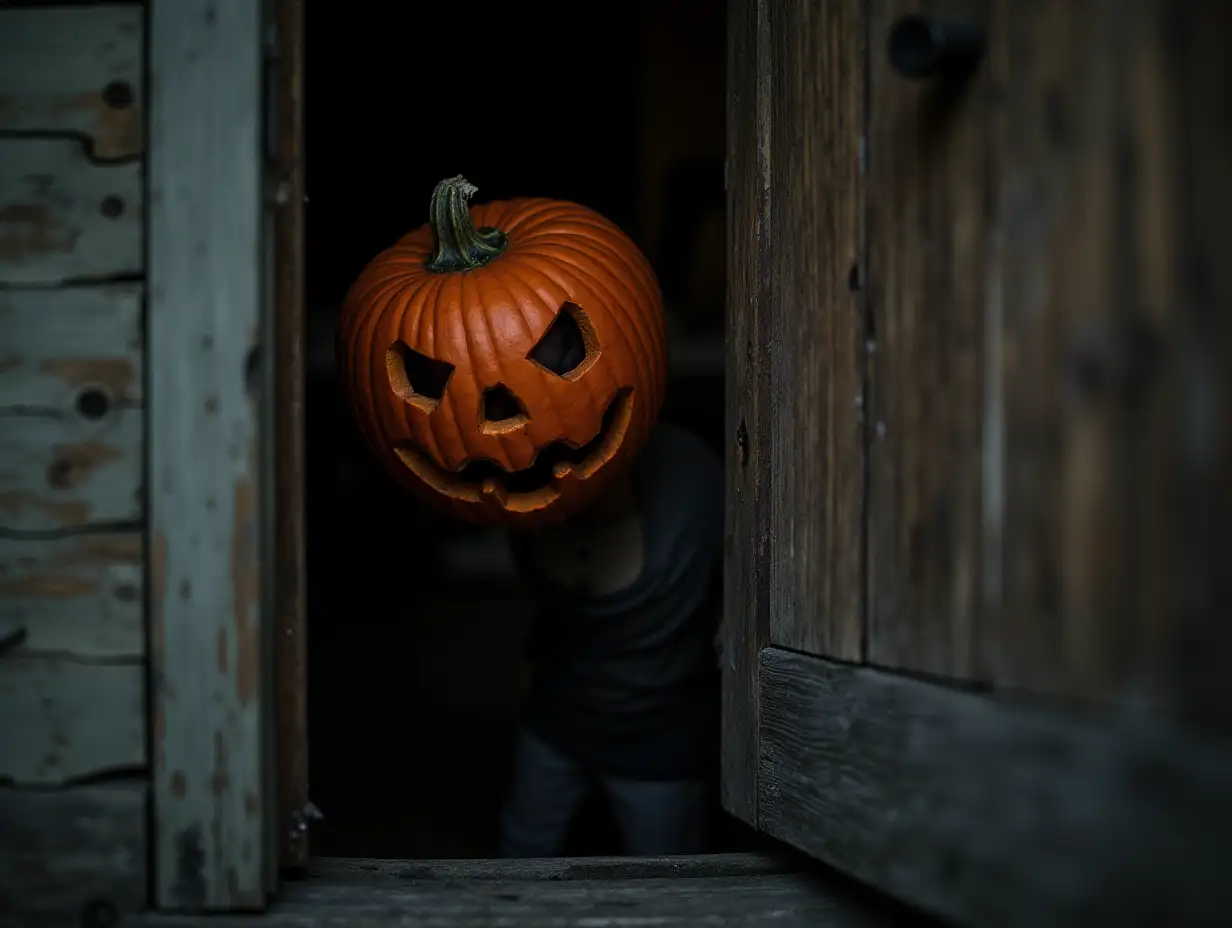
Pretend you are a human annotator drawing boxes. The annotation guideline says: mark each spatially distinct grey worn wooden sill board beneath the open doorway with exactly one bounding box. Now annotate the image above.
[124,861,930,928]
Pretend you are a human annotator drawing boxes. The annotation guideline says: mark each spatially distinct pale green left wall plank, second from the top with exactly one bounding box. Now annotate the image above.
[0,138,144,285]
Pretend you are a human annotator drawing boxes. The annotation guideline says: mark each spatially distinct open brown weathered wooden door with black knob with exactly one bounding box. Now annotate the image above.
[723,0,1232,926]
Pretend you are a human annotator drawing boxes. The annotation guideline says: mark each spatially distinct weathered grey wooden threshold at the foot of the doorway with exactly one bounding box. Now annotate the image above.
[122,854,931,928]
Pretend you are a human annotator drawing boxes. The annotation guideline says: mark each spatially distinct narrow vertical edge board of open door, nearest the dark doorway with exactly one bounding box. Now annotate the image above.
[721,0,771,826]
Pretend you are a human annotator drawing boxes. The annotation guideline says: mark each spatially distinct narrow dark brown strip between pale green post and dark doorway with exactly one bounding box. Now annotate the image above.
[274,0,309,869]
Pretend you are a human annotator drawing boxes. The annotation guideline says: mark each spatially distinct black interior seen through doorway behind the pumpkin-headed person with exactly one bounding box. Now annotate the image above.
[306,0,755,858]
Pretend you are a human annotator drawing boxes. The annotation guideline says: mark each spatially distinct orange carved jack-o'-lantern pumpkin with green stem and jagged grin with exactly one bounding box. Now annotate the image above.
[338,177,667,527]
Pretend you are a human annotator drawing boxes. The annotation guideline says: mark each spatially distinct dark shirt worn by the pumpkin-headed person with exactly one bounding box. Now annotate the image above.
[513,423,723,780]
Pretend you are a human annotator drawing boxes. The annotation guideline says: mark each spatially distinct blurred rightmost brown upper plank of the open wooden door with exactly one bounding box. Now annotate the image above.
[979,0,1232,722]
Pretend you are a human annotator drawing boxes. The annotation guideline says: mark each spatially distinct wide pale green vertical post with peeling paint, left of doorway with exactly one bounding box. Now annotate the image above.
[148,0,267,910]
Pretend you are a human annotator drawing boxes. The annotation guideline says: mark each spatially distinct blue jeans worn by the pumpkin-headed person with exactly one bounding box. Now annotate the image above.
[500,730,707,858]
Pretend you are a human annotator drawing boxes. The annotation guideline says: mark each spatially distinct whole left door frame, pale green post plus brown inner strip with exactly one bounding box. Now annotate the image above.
[147,0,309,912]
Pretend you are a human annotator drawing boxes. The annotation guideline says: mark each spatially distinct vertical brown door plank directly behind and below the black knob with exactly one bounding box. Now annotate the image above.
[866,0,997,678]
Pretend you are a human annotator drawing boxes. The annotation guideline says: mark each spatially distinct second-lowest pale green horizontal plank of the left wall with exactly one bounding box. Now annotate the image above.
[0,643,145,786]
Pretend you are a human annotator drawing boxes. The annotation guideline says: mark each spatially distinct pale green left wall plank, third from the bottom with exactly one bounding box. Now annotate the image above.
[0,530,145,659]
